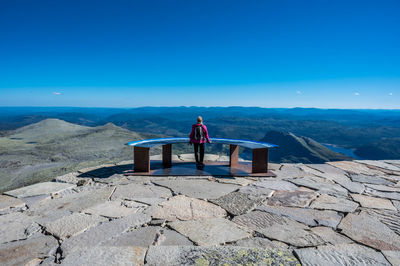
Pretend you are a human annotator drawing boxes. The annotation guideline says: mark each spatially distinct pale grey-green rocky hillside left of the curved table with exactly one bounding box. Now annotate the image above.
[0,119,159,191]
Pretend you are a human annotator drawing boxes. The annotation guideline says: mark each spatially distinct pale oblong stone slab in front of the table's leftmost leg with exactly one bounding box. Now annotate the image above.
[112,184,172,200]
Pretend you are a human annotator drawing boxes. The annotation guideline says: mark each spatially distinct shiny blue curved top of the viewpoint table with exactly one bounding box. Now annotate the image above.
[126,138,278,149]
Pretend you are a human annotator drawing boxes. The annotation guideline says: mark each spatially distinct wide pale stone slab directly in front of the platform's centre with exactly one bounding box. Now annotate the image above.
[153,180,240,199]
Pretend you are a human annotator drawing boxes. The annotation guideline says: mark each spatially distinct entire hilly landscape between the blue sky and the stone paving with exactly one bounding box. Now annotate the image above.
[0,107,400,190]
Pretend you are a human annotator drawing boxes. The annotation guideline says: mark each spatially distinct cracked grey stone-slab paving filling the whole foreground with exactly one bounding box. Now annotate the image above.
[0,156,400,265]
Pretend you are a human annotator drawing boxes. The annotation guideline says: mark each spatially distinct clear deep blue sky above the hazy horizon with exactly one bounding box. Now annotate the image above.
[0,0,400,109]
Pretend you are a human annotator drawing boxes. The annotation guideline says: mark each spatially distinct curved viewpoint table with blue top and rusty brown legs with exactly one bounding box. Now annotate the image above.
[126,138,277,174]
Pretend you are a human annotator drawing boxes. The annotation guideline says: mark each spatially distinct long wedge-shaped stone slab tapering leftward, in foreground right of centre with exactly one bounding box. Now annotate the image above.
[257,205,342,228]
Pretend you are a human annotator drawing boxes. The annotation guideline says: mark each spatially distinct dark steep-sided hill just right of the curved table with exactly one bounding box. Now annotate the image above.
[261,131,351,163]
